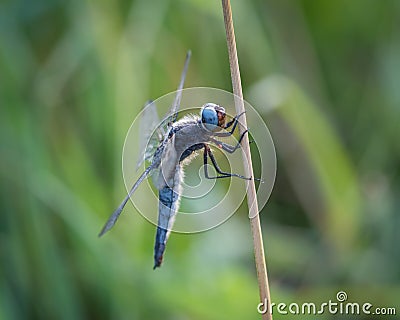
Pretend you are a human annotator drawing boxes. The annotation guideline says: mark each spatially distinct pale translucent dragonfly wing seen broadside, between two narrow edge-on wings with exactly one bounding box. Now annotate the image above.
[136,100,165,169]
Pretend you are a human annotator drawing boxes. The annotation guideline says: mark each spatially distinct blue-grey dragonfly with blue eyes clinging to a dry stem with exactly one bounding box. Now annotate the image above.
[99,51,253,269]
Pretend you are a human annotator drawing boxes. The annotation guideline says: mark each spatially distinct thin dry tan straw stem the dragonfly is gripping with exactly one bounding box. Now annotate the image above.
[222,0,272,319]
